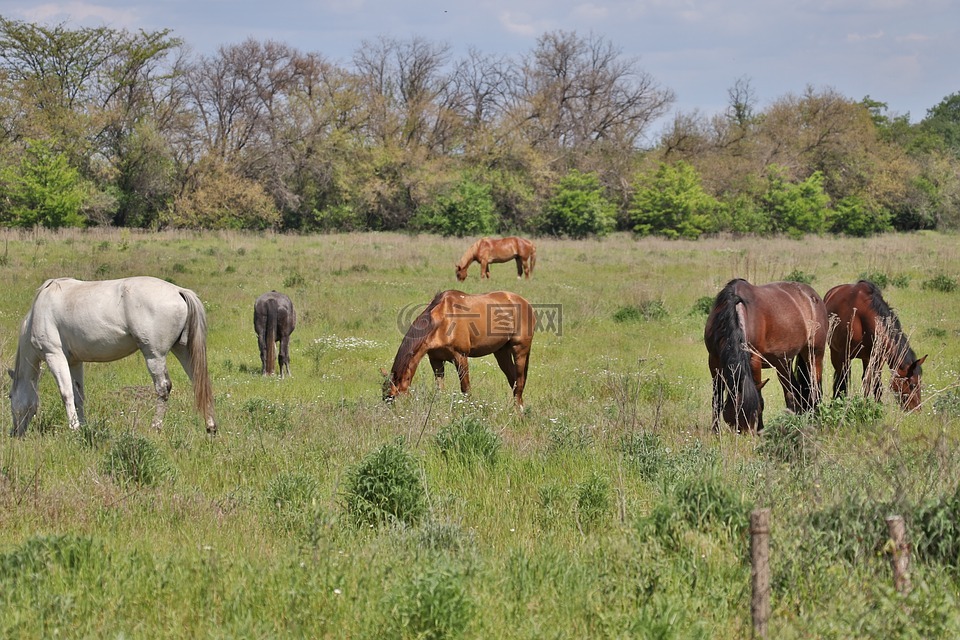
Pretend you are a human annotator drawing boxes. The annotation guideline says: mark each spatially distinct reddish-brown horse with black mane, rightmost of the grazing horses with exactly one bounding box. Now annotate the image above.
[823,280,927,411]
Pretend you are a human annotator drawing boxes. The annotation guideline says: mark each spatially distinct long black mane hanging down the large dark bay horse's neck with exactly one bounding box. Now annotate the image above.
[713,279,760,422]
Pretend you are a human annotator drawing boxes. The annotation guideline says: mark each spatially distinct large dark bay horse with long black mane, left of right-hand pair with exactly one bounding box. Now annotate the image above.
[703,278,828,431]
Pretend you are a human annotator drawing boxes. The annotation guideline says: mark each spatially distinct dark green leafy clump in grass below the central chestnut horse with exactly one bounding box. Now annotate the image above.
[343,442,426,526]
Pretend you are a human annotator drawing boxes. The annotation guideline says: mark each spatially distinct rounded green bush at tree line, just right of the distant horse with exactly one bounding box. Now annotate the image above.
[537,170,617,238]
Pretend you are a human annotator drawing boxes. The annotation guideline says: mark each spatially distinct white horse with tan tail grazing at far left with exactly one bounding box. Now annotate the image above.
[10,276,217,436]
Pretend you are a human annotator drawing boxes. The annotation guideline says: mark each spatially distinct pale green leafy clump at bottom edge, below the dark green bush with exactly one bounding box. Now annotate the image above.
[386,560,476,640]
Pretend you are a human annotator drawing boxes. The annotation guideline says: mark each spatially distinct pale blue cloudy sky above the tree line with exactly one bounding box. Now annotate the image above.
[0,0,960,134]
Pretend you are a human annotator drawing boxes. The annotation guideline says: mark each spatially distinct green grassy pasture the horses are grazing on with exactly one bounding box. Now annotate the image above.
[0,230,960,638]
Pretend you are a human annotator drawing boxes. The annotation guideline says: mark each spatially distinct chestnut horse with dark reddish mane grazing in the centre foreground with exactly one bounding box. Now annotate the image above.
[381,290,535,410]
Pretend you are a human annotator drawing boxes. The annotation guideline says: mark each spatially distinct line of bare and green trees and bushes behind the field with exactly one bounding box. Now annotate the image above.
[0,17,960,238]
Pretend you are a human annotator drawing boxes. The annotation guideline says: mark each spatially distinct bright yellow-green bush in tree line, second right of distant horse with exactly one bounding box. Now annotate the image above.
[627,160,719,239]
